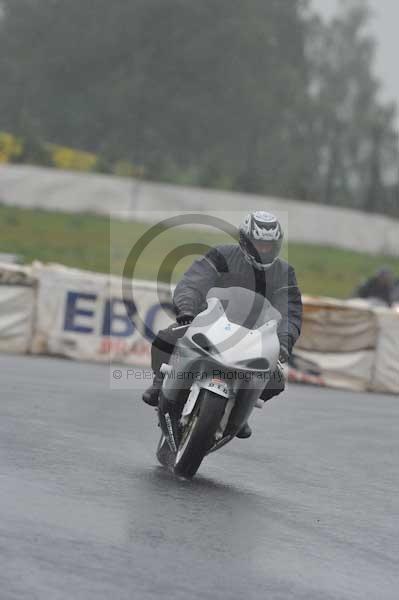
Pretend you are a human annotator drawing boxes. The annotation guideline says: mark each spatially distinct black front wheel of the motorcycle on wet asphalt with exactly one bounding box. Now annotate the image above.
[174,389,227,479]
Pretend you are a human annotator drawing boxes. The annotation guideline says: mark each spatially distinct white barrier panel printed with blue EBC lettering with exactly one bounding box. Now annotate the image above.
[32,265,171,366]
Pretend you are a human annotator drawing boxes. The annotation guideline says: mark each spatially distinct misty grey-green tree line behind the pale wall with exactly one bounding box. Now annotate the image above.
[0,0,399,216]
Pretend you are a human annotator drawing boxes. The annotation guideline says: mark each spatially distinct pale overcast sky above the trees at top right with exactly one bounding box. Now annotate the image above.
[313,0,399,118]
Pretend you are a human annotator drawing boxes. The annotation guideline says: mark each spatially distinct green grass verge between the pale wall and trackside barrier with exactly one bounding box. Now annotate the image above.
[0,206,399,298]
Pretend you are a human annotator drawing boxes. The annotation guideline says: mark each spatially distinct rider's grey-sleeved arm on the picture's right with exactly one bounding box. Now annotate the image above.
[272,265,303,355]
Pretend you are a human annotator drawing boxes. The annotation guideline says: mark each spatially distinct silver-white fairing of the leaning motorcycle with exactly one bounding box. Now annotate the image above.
[162,288,280,441]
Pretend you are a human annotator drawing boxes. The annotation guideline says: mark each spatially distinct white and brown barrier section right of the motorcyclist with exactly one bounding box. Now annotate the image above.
[291,297,399,393]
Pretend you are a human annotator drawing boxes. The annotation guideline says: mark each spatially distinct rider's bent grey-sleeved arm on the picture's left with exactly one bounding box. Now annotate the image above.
[173,249,221,315]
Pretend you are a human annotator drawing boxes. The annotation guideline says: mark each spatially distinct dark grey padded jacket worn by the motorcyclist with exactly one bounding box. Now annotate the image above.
[173,244,302,354]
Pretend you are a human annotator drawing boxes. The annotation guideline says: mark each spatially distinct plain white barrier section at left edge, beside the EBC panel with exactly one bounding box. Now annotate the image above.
[0,264,36,354]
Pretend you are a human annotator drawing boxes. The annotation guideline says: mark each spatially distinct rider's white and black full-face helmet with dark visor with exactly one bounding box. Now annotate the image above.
[239,211,284,271]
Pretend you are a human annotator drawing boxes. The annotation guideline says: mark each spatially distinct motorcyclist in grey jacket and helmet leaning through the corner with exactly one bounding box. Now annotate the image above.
[143,211,302,438]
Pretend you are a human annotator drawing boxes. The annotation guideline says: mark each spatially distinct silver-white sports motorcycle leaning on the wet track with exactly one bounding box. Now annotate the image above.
[157,287,281,479]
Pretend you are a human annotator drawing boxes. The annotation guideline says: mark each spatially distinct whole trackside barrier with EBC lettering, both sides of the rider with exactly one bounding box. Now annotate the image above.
[0,263,399,394]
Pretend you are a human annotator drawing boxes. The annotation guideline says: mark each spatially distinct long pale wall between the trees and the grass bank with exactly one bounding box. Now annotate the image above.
[0,165,399,256]
